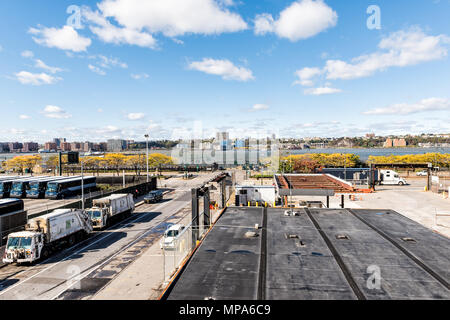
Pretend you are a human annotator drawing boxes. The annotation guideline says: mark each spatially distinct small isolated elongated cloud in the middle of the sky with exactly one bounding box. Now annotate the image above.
[188,58,255,81]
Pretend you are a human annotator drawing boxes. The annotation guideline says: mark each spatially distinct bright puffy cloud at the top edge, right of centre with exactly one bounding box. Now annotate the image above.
[255,0,338,42]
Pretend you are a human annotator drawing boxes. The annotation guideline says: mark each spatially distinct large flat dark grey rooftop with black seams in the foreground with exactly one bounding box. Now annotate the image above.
[168,207,450,300]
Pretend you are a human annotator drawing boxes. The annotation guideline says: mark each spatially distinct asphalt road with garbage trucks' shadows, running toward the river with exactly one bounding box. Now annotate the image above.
[0,174,214,300]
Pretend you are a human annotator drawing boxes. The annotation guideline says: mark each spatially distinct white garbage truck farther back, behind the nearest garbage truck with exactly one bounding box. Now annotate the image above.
[87,194,134,229]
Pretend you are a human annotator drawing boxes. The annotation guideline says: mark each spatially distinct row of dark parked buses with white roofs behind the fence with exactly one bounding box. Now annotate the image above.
[0,176,97,199]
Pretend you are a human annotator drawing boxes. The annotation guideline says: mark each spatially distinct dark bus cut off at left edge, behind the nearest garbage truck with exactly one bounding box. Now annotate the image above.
[0,199,27,247]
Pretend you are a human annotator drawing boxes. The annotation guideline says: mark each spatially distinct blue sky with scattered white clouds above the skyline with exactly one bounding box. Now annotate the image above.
[0,0,450,142]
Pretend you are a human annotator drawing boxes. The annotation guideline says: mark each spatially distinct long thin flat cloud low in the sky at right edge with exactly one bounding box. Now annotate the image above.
[364,98,450,115]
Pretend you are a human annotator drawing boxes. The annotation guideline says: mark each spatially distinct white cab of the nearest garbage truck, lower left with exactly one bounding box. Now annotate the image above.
[3,231,45,263]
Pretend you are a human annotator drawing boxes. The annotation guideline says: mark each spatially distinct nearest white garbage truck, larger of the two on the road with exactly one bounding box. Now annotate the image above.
[3,209,92,263]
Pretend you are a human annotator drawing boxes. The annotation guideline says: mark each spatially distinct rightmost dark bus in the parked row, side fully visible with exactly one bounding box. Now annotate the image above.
[45,176,97,199]
